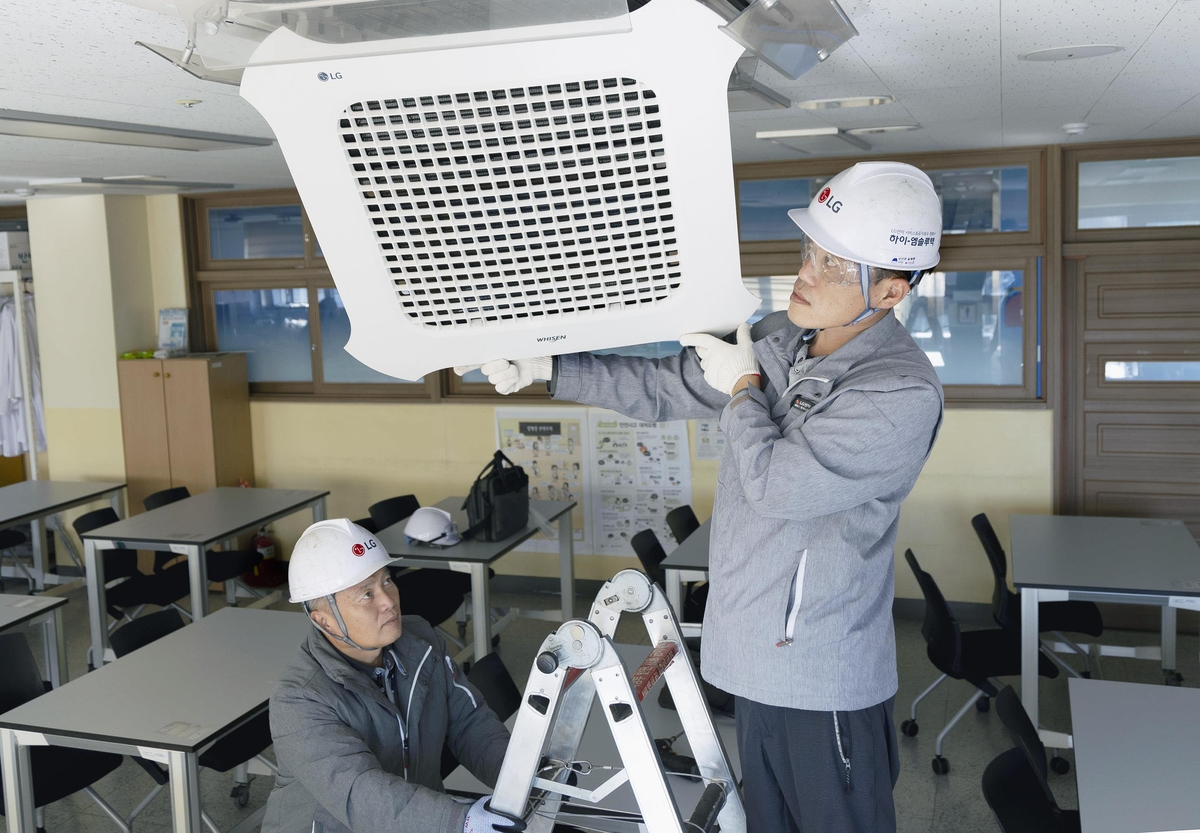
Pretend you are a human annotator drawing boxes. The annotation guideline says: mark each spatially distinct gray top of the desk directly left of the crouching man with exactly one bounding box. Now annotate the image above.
[0,607,312,753]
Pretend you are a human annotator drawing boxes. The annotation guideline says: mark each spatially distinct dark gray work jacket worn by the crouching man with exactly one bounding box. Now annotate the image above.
[263,616,509,833]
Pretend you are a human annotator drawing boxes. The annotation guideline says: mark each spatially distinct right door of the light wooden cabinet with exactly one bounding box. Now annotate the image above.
[162,359,217,495]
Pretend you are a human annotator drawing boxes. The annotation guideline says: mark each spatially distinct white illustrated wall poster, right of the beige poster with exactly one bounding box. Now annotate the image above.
[588,408,691,556]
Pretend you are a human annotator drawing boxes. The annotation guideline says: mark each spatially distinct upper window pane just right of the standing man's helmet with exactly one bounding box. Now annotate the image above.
[929,164,1030,234]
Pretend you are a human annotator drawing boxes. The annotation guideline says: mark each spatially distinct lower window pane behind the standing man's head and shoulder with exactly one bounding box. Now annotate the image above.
[896,269,1024,385]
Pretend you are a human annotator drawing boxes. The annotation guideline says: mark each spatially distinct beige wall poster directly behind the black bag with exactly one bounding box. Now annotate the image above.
[496,408,590,552]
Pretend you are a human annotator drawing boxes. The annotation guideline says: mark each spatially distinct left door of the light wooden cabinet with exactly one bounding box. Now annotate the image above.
[116,359,170,515]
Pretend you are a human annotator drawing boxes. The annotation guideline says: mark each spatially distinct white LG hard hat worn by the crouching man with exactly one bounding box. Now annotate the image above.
[288,517,398,604]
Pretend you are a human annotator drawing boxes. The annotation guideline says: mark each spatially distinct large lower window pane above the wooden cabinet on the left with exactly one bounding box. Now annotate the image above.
[212,287,312,382]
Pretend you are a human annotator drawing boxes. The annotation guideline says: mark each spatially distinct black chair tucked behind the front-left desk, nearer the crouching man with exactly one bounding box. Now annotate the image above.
[110,610,277,811]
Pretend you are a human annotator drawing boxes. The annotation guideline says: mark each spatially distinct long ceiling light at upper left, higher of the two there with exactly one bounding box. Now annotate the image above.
[0,109,274,150]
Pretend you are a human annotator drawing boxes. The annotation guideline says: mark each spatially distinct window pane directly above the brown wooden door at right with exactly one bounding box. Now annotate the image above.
[1079,156,1200,228]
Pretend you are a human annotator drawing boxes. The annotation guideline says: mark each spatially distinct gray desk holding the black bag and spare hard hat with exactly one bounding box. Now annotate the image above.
[376,497,577,661]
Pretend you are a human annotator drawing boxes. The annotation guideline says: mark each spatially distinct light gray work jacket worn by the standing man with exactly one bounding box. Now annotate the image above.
[552,312,942,711]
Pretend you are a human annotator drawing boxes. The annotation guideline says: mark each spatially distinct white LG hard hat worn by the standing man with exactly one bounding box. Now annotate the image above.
[787,162,942,271]
